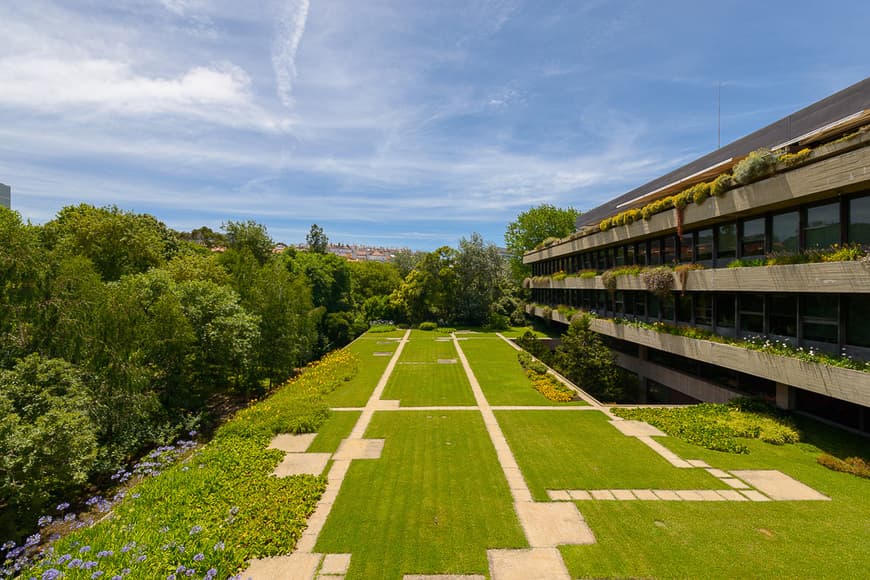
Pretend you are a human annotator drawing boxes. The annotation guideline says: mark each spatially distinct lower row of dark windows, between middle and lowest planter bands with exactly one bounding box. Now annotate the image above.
[532,289,870,350]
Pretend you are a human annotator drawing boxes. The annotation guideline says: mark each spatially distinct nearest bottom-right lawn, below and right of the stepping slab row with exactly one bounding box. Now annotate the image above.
[562,420,870,578]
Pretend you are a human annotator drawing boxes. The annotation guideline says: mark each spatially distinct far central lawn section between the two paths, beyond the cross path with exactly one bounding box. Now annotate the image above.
[383,330,475,407]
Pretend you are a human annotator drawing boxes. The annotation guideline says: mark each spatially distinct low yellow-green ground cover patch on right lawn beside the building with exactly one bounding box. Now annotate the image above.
[613,399,800,453]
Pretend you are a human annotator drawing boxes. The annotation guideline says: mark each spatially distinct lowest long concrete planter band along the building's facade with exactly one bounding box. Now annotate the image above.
[592,319,870,406]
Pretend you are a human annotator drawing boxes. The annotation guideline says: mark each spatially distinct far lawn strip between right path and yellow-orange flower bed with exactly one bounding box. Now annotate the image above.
[460,334,586,406]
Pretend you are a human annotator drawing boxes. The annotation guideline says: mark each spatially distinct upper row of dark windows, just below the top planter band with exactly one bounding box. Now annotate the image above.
[532,192,870,276]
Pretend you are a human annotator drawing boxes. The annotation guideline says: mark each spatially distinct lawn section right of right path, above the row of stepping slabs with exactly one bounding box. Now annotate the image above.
[496,411,726,500]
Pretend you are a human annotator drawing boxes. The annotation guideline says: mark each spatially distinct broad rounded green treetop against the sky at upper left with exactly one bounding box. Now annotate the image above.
[44,204,178,280]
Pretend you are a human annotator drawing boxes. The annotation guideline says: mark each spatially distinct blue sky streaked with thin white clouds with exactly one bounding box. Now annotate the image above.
[0,0,870,250]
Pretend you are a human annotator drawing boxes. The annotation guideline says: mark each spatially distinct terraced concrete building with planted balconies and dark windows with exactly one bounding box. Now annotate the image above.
[524,78,870,432]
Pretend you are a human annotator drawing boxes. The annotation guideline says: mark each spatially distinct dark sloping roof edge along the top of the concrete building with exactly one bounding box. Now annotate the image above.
[576,77,870,229]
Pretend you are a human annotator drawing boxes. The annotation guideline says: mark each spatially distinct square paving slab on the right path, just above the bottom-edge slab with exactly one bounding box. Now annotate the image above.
[515,502,595,548]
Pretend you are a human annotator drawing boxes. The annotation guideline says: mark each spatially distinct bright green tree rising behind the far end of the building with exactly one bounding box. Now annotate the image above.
[504,203,580,283]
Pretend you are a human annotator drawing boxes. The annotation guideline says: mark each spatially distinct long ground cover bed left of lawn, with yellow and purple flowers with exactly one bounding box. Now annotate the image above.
[4,351,359,578]
